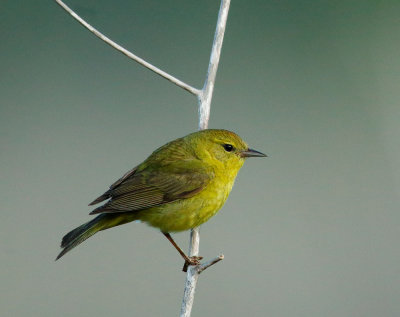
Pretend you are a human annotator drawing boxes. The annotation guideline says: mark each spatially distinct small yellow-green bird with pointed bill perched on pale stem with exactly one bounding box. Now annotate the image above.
[56,129,266,265]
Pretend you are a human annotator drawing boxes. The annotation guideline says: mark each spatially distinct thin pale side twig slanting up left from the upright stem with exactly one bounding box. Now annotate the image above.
[55,0,200,96]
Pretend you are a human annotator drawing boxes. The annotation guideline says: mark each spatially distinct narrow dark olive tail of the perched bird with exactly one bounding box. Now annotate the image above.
[56,213,135,261]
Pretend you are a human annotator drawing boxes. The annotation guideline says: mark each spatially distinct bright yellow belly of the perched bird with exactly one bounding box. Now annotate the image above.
[138,181,232,232]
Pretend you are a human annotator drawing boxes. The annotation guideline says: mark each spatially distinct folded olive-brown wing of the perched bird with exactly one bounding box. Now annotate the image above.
[90,159,213,214]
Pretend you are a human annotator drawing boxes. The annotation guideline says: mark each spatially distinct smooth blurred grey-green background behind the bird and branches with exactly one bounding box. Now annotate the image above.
[0,0,400,317]
